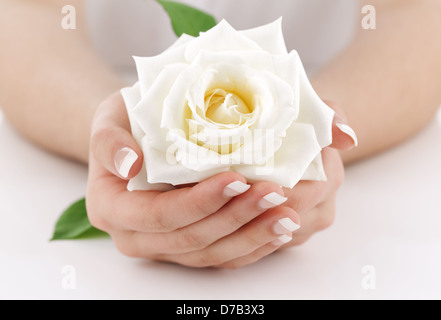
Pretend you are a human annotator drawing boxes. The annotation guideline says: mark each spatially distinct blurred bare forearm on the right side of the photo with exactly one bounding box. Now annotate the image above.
[313,0,441,163]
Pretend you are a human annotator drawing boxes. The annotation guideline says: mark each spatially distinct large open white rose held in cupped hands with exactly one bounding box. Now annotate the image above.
[122,19,334,190]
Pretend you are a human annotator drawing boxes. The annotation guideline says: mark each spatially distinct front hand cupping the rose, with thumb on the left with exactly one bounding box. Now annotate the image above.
[86,93,299,267]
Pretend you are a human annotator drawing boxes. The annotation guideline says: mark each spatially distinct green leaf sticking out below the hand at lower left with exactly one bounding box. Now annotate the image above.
[51,198,109,241]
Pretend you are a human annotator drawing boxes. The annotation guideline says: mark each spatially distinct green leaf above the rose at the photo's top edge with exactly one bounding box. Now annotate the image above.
[157,0,217,37]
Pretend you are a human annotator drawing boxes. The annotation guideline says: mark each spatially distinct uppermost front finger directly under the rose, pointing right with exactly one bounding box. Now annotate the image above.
[90,172,249,232]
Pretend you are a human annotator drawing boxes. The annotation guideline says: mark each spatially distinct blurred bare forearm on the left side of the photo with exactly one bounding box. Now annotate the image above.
[0,0,123,162]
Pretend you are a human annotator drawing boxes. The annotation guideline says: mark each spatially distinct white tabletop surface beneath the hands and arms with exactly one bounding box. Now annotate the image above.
[0,108,441,299]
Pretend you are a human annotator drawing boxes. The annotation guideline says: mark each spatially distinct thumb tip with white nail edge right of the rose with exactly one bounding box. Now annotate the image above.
[325,101,358,150]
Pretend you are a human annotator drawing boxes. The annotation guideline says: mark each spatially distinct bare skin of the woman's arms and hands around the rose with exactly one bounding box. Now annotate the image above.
[0,0,441,268]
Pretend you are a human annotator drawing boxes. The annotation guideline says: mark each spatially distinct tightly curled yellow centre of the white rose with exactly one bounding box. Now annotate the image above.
[205,89,252,125]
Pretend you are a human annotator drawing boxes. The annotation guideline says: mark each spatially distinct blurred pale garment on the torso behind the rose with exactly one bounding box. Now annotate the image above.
[86,0,361,80]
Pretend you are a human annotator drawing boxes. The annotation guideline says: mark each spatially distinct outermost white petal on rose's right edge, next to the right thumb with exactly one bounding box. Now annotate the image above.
[296,55,334,148]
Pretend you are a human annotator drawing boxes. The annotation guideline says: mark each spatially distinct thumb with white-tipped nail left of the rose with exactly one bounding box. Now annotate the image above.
[90,93,143,179]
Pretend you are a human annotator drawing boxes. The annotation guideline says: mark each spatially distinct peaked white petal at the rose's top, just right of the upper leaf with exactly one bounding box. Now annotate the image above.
[185,20,262,61]
